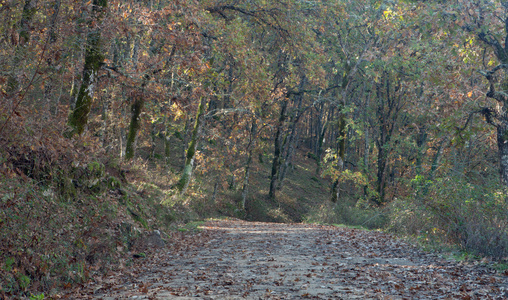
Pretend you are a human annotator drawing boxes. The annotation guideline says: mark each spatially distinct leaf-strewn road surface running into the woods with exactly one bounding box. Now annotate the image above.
[68,220,508,299]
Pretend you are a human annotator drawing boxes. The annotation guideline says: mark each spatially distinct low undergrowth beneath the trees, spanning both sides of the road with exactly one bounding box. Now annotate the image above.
[0,110,508,298]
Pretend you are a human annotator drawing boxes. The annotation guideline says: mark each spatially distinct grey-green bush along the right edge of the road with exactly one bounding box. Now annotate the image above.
[389,178,508,259]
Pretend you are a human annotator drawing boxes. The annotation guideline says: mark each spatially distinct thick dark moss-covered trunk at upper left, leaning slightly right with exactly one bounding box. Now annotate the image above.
[67,0,108,137]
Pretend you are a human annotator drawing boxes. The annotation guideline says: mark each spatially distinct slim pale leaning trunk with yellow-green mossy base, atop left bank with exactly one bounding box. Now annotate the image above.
[177,97,206,194]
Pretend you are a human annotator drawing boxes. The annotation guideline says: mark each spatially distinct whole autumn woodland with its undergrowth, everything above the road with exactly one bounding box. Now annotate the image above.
[0,0,508,296]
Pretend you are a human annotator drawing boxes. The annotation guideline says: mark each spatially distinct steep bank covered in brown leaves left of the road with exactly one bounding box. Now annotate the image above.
[0,151,189,299]
